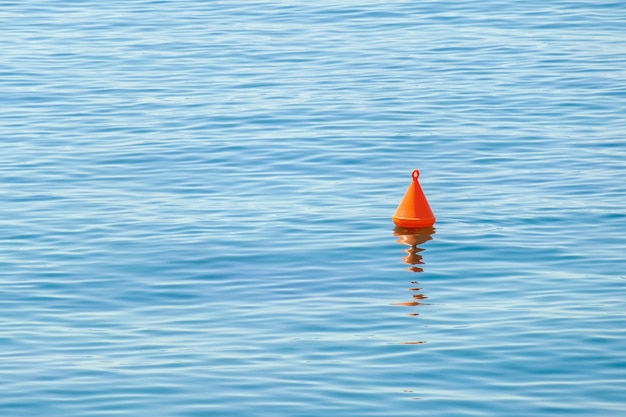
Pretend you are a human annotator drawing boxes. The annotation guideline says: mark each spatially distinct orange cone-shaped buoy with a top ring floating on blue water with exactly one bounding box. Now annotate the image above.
[391,169,435,229]
